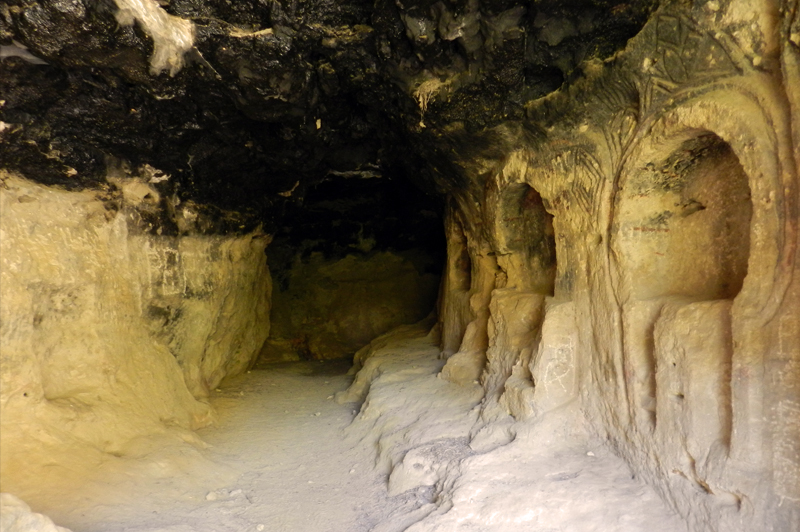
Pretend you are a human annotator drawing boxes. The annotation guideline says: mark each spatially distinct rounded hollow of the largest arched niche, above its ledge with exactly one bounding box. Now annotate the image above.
[614,130,753,300]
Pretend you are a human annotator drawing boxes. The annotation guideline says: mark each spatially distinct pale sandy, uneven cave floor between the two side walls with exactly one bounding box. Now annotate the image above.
[17,338,685,532]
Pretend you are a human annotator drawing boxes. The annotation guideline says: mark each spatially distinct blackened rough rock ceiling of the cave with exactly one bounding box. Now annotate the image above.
[0,0,657,230]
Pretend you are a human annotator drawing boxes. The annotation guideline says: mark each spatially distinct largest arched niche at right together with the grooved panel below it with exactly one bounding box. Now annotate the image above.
[612,128,753,489]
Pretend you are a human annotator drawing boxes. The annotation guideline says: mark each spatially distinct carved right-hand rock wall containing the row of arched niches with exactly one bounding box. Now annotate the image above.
[441,0,800,531]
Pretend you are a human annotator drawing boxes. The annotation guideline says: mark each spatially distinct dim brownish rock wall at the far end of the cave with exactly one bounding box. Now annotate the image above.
[261,251,439,362]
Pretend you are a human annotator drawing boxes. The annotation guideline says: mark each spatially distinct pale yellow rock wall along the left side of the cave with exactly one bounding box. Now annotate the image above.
[0,174,271,496]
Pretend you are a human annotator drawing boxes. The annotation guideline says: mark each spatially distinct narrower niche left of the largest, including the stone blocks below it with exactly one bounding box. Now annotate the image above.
[489,183,576,418]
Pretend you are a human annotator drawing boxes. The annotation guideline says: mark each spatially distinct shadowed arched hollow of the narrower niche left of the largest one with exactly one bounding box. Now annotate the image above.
[494,183,556,296]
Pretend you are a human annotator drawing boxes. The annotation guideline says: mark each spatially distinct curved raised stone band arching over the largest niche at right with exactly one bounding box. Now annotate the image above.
[632,89,798,318]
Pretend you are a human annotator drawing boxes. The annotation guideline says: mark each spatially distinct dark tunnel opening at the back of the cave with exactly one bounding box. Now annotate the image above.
[258,169,447,365]
